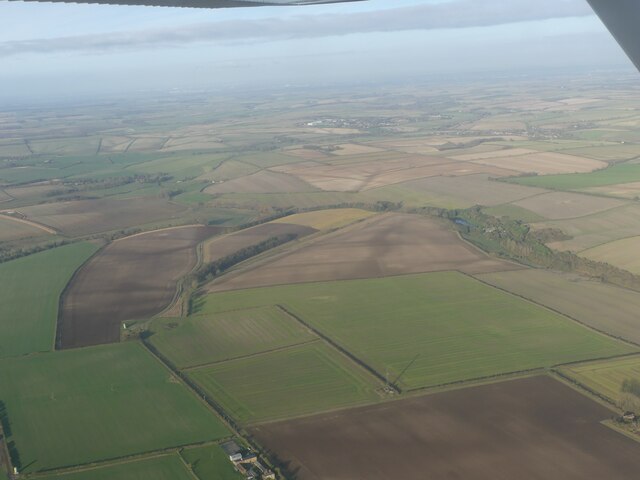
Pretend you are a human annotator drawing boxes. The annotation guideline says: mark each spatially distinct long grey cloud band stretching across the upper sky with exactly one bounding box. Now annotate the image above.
[0,0,593,57]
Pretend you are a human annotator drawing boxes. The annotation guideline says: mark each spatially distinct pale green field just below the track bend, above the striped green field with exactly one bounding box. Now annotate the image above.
[150,307,315,368]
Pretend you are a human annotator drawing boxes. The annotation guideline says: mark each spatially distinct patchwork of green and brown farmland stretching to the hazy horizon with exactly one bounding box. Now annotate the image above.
[6,80,640,480]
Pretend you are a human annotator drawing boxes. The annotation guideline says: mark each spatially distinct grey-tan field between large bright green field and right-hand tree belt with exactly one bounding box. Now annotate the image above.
[475,269,640,344]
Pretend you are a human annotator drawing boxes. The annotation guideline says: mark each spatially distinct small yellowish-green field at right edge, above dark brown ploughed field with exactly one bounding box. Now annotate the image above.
[561,356,640,404]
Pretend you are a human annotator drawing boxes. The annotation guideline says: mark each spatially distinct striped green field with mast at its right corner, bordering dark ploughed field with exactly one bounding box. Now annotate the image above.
[189,342,379,423]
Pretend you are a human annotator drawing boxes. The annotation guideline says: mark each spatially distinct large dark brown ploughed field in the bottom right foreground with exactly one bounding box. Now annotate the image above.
[251,377,640,480]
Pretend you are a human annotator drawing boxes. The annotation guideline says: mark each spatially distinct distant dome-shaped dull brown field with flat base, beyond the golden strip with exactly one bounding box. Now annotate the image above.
[204,170,315,194]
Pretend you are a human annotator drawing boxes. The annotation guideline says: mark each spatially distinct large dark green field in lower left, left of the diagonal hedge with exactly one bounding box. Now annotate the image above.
[0,342,229,473]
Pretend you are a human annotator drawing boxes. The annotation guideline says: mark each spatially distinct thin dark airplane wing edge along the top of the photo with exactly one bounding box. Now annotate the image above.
[10,0,362,8]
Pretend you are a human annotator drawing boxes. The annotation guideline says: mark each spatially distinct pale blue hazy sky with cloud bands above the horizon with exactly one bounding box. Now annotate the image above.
[0,0,631,103]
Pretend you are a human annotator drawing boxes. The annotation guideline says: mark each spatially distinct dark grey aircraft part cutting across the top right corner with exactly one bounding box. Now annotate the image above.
[587,0,640,70]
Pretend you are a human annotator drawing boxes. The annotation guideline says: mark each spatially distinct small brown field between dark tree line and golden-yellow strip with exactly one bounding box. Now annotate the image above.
[203,223,318,262]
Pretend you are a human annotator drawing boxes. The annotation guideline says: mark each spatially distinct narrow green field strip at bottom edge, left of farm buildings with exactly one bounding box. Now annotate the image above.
[38,454,192,480]
